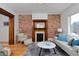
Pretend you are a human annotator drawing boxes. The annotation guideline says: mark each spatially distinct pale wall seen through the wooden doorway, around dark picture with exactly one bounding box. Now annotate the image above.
[0,14,9,42]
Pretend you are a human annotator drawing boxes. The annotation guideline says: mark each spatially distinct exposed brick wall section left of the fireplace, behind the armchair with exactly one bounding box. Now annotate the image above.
[19,15,32,37]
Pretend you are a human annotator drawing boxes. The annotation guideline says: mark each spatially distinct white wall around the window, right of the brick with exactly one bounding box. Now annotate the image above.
[61,4,79,34]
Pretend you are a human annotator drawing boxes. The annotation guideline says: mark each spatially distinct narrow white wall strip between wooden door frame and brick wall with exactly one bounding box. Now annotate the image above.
[0,3,18,43]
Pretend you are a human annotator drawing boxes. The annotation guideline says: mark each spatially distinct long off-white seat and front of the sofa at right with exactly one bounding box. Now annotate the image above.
[54,40,77,56]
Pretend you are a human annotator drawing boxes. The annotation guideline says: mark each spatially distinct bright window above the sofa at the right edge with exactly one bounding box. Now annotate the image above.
[70,13,79,34]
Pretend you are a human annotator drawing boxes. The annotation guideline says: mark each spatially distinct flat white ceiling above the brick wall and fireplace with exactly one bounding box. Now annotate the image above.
[7,3,72,14]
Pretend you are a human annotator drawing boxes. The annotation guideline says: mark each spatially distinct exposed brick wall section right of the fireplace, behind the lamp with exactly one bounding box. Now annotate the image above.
[48,15,60,38]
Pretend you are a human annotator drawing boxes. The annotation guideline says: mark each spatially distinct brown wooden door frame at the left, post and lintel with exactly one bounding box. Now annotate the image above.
[0,8,14,45]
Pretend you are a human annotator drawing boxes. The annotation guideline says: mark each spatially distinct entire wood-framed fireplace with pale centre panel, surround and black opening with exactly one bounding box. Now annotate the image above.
[32,19,48,42]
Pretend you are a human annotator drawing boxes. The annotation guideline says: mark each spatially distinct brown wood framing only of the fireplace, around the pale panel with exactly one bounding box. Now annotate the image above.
[32,20,48,42]
